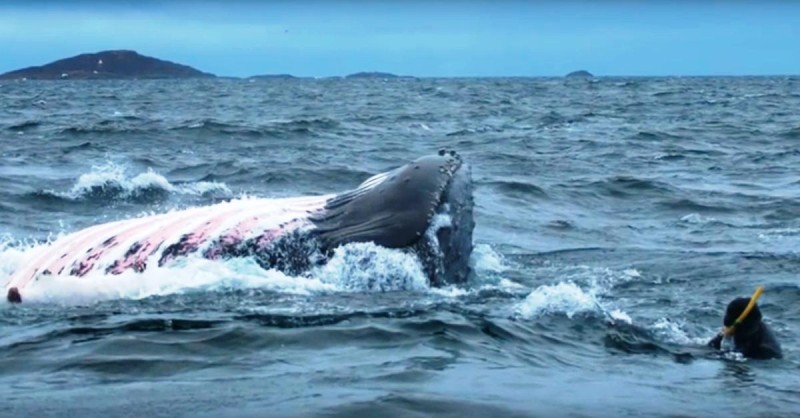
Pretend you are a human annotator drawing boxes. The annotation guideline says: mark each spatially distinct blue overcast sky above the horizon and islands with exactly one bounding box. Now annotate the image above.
[0,0,800,76]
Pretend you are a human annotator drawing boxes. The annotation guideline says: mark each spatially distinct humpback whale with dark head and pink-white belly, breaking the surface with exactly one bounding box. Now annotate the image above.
[5,150,475,303]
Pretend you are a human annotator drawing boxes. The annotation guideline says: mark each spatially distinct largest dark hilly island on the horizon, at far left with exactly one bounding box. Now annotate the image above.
[0,50,216,80]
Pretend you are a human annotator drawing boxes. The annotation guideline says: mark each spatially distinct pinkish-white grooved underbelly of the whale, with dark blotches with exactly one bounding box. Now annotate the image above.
[5,195,333,293]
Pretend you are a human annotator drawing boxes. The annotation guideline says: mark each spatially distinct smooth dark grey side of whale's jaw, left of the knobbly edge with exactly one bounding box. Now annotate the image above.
[310,154,460,249]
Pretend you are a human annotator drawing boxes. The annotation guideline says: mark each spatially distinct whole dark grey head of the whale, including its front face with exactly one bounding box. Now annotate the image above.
[310,150,475,286]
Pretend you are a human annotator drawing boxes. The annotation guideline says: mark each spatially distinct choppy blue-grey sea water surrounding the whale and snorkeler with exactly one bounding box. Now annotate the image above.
[0,77,800,418]
